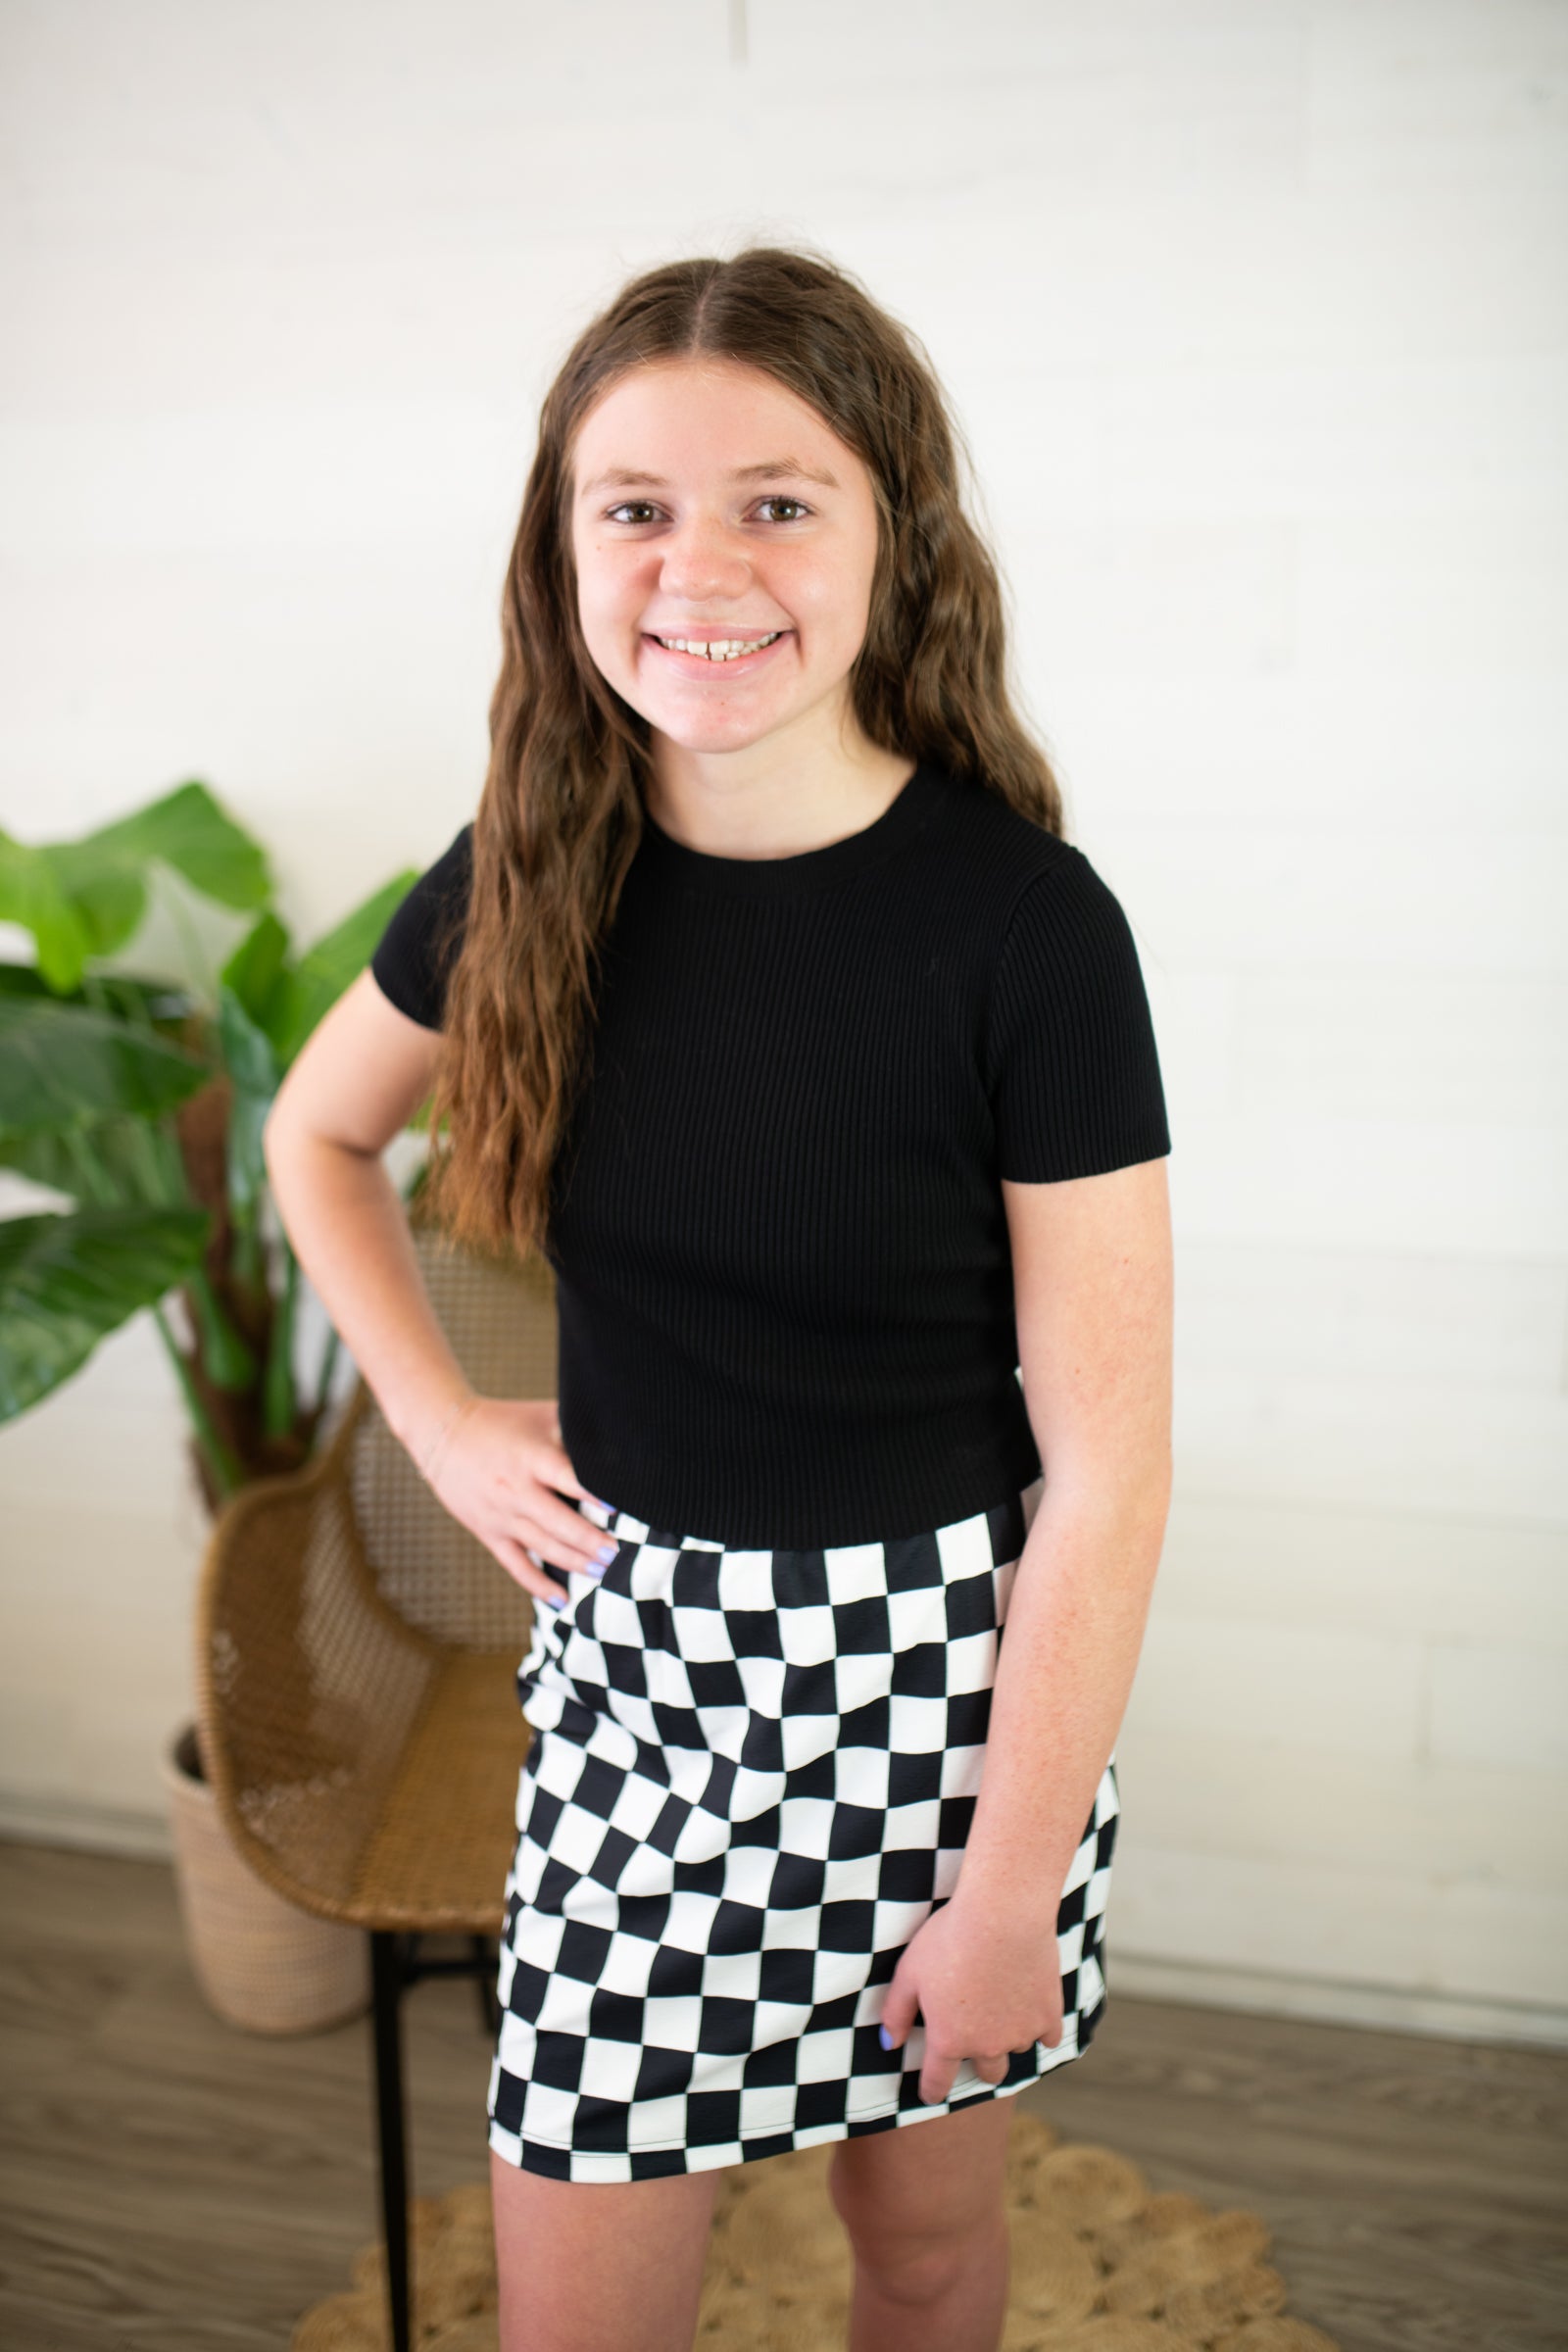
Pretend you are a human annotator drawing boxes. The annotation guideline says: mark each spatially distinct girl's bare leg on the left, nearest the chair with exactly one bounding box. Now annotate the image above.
[489,2147,724,2352]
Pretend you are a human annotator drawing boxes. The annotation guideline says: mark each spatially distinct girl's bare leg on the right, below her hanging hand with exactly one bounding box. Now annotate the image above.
[827,2098,1013,2352]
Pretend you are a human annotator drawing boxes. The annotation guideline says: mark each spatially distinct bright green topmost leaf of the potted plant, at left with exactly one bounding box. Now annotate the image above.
[0,781,272,990]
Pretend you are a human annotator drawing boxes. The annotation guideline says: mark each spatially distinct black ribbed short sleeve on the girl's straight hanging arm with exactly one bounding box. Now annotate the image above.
[987,842,1171,1183]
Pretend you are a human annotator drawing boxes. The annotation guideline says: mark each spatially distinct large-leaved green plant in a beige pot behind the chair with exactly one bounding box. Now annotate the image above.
[0,781,420,2033]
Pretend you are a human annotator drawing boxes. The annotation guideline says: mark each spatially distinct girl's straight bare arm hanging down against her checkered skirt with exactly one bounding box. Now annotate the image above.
[884,1159,1173,2103]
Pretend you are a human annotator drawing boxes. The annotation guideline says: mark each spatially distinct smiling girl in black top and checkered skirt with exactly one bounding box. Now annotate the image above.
[268,249,1171,2352]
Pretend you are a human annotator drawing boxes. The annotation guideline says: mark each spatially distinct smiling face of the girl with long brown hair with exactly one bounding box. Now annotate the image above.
[571,360,877,753]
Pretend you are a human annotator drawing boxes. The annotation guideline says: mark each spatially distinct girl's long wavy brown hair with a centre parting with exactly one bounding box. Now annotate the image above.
[420,245,1062,1256]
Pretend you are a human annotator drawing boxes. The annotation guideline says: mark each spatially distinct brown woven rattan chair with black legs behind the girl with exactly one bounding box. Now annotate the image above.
[195,1225,555,2352]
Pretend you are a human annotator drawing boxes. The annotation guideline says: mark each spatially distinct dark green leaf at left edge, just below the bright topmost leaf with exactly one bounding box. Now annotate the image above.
[0,998,209,1139]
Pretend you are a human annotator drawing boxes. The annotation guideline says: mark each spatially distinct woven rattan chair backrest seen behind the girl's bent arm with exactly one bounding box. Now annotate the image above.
[348,1223,558,1653]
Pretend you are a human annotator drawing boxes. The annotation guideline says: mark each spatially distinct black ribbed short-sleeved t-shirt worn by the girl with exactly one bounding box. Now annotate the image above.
[371,766,1171,1550]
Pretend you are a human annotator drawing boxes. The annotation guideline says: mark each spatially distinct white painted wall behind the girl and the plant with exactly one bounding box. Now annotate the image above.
[0,0,1568,2034]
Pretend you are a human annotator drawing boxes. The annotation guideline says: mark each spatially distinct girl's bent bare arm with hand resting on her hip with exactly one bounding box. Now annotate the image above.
[261,971,604,1599]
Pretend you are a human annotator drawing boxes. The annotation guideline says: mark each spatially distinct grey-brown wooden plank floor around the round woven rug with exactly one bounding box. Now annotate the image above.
[0,1844,1568,2352]
